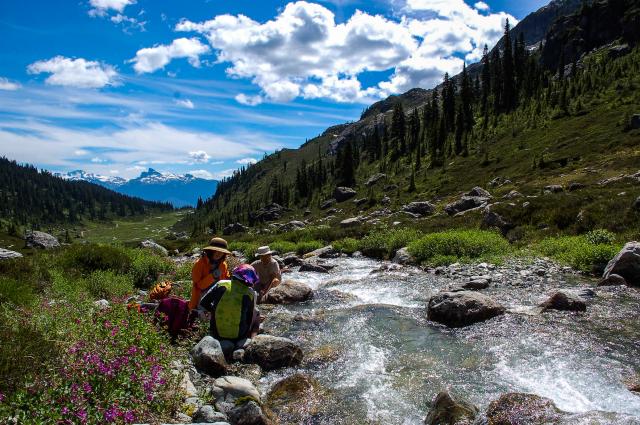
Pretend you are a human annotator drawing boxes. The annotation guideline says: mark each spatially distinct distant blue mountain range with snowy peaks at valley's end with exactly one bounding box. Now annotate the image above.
[56,168,218,208]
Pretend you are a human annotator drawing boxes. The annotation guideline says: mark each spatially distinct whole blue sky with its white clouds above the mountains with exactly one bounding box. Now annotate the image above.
[0,0,543,178]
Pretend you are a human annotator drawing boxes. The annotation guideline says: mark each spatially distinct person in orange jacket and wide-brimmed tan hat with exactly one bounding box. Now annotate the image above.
[189,238,231,310]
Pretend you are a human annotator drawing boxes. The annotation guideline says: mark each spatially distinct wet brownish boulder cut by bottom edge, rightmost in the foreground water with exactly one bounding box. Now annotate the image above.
[486,393,563,425]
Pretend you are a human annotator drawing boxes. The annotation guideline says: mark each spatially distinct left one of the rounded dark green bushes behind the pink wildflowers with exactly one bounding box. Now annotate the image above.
[59,244,133,274]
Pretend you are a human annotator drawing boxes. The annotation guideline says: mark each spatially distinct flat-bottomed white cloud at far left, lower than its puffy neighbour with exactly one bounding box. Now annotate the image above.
[27,56,118,88]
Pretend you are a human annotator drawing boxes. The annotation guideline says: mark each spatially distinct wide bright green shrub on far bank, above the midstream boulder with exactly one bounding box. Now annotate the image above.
[409,230,511,265]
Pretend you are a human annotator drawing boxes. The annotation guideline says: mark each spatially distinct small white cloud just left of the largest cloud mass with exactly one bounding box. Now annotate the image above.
[130,37,211,74]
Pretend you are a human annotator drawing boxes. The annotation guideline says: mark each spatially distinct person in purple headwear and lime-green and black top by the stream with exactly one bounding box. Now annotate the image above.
[200,264,260,357]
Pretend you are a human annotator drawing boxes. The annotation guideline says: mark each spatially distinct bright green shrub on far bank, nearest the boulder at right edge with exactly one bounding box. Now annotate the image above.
[535,235,620,274]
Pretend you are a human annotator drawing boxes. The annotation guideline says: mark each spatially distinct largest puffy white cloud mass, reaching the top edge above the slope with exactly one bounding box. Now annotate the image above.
[175,0,516,105]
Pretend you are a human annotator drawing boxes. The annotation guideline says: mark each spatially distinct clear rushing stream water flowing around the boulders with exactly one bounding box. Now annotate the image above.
[261,258,640,424]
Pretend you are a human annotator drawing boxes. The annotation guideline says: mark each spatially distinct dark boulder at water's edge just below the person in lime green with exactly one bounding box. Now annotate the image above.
[244,335,302,370]
